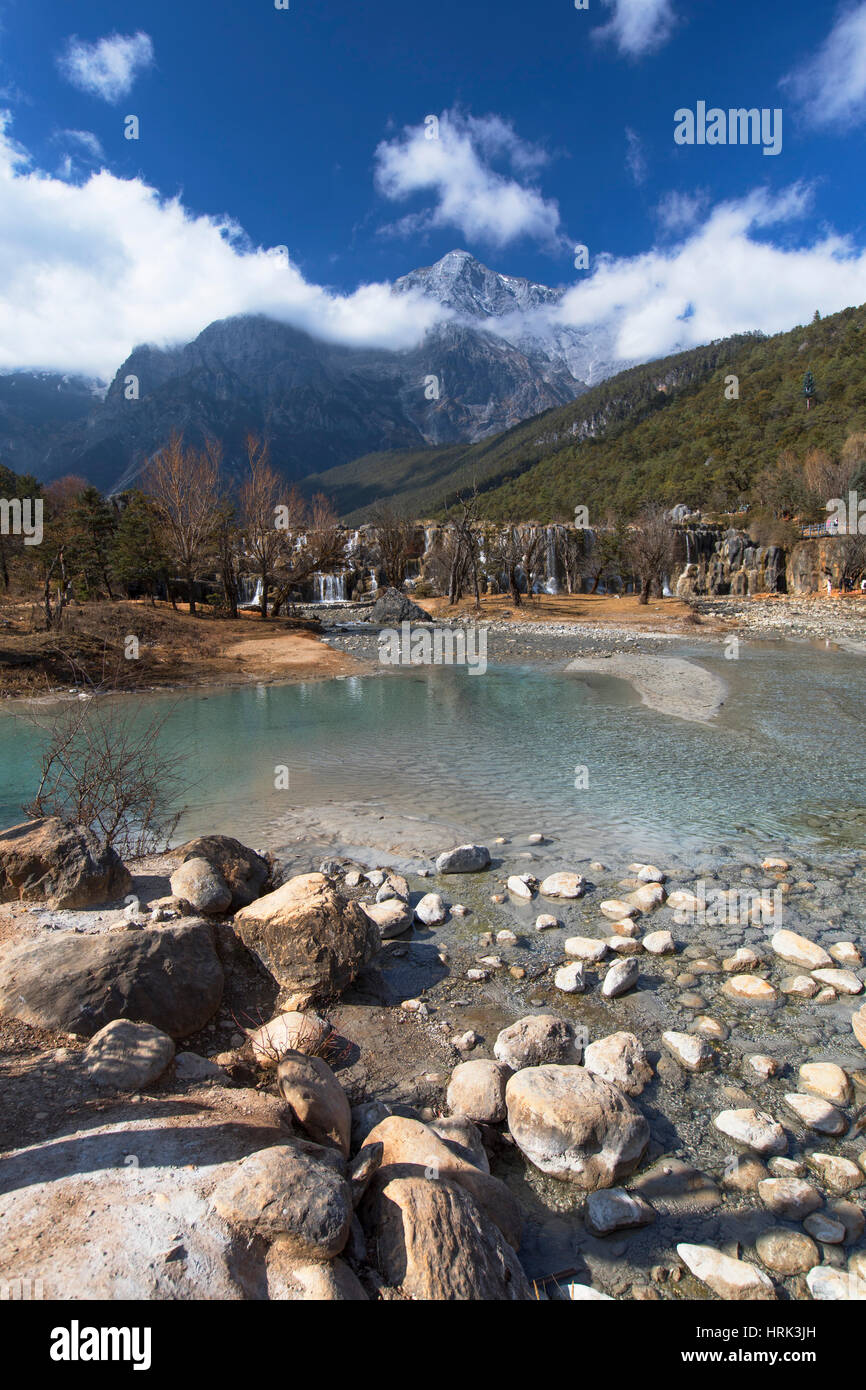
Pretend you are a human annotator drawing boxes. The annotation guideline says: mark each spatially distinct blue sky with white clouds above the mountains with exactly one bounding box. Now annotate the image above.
[0,0,866,375]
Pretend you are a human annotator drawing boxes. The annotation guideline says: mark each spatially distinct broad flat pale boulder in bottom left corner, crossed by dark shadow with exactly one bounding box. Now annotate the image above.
[0,1087,296,1302]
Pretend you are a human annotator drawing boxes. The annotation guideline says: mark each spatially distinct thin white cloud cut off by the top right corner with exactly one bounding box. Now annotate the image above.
[781,0,866,128]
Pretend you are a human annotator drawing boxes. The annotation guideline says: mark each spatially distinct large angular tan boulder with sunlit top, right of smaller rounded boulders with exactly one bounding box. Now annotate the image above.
[235,873,379,1009]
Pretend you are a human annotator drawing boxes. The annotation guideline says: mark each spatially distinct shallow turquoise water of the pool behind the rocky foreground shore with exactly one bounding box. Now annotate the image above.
[0,644,866,856]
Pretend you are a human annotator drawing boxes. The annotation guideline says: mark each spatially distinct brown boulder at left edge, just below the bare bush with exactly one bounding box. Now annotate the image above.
[0,816,132,908]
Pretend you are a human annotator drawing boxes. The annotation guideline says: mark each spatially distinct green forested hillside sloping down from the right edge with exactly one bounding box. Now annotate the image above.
[307,307,866,521]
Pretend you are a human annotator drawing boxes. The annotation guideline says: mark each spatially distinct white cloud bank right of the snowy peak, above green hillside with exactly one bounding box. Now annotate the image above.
[556,185,866,361]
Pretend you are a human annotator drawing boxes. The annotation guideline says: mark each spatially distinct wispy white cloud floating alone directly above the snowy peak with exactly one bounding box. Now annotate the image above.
[375,111,562,247]
